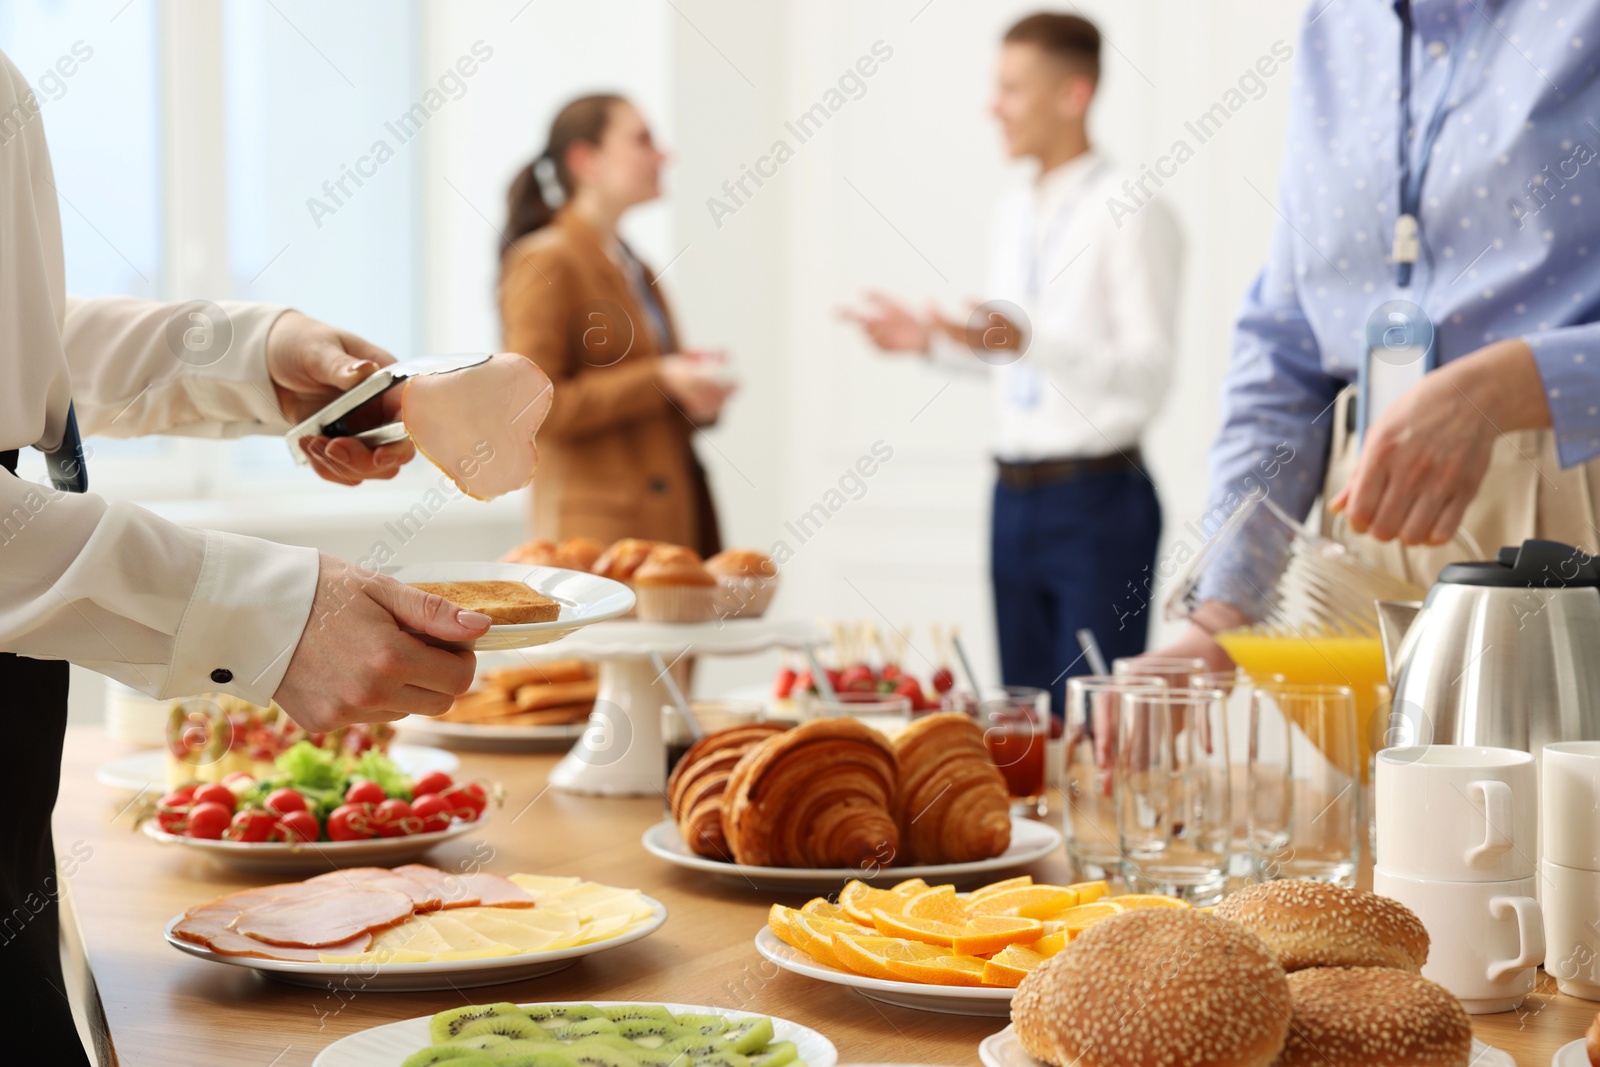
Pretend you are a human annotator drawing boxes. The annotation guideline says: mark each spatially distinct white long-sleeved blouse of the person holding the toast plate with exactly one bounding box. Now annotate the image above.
[0,54,318,704]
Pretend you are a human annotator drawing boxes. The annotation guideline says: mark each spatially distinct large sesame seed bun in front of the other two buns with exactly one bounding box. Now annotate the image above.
[1011,907,1290,1067]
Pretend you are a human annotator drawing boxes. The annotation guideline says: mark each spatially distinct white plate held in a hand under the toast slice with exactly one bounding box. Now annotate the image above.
[382,561,634,653]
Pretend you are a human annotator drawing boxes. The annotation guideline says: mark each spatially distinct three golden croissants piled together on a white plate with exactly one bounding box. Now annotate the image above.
[667,712,1011,869]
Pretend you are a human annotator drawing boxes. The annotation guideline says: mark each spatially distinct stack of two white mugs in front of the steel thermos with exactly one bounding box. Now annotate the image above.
[1373,745,1542,1014]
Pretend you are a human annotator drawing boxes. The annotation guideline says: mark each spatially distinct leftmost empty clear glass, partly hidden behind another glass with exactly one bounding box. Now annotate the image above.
[1062,675,1166,881]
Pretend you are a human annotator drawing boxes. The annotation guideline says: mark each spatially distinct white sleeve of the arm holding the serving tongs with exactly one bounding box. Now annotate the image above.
[61,296,290,437]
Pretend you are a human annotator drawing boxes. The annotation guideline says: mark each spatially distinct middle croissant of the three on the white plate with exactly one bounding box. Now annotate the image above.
[722,718,899,869]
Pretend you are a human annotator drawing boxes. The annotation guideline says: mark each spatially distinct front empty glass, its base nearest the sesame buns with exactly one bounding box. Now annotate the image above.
[1115,689,1234,904]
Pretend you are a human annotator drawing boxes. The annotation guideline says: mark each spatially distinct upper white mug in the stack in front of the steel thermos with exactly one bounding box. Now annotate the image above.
[1376,745,1539,881]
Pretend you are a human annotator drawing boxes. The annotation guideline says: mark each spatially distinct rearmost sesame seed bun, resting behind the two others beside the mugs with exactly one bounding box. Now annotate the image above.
[1213,878,1427,974]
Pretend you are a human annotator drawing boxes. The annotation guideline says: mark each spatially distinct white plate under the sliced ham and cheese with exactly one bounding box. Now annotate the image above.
[166,896,667,991]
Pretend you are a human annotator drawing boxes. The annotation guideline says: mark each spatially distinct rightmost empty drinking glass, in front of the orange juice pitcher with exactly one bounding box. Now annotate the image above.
[1248,683,1365,886]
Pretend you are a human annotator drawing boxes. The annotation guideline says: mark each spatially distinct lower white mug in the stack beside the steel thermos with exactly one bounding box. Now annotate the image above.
[1373,867,1544,1016]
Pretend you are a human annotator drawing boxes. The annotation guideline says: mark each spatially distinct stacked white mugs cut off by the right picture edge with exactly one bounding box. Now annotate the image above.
[1539,741,1600,1000]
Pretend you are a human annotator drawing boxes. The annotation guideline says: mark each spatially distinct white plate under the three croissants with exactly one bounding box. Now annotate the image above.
[640,816,1061,893]
